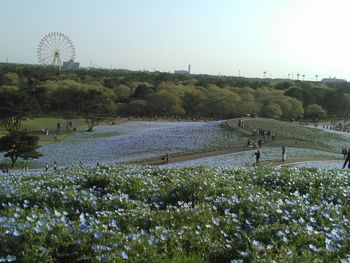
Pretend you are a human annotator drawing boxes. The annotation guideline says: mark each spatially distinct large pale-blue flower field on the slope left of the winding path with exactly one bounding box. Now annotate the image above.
[23,121,245,166]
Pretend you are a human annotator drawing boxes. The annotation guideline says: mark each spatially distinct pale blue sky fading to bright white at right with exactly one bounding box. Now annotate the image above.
[0,0,350,80]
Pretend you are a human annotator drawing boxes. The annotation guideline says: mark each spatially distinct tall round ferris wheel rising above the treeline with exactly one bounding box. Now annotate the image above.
[37,32,75,67]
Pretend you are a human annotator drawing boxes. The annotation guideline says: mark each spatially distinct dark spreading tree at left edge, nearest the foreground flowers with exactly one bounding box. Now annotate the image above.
[0,131,42,167]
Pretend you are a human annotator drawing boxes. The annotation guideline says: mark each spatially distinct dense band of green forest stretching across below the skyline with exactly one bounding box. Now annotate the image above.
[0,64,350,122]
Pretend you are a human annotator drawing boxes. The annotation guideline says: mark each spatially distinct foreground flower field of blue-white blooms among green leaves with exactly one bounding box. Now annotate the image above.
[0,166,350,262]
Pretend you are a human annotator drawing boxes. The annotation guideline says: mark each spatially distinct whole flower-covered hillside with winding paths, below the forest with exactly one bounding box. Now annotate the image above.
[0,118,350,167]
